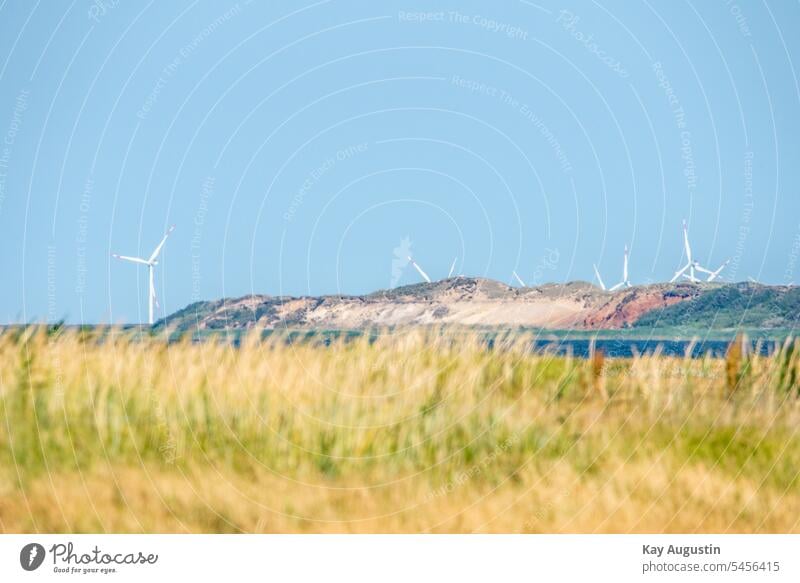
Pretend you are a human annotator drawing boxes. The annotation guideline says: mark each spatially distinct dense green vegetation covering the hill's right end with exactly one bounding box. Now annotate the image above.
[634,283,800,330]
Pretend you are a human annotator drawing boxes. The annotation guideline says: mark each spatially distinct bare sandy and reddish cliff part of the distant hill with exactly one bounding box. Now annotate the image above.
[166,277,720,329]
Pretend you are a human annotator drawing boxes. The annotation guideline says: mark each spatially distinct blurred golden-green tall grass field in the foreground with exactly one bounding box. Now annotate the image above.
[0,327,800,533]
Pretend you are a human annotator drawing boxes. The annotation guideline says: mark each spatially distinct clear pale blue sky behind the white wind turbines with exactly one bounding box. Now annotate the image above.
[0,0,800,323]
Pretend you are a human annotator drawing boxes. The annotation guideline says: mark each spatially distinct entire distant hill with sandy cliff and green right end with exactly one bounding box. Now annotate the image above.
[156,277,800,331]
